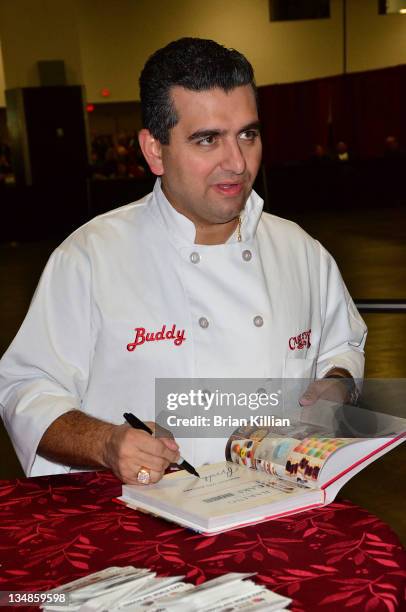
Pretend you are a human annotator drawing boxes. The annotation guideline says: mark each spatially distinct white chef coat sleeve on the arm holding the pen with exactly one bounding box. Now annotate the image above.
[0,245,93,476]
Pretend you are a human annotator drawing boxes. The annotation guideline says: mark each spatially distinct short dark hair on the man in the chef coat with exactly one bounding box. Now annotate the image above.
[140,38,256,144]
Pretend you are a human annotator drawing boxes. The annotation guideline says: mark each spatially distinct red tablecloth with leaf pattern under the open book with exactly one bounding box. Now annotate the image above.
[0,472,406,612]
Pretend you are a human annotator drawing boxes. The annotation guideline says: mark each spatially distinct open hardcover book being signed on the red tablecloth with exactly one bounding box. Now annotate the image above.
[120,412,405,535]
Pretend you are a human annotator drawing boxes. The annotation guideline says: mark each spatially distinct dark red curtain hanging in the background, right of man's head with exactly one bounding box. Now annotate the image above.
[258,65,406,165]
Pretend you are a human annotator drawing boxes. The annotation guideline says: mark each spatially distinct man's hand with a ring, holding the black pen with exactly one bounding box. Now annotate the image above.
[103,423,179,484]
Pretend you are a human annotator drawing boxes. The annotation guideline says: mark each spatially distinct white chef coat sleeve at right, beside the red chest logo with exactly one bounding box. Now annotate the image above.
[316,245,367,379]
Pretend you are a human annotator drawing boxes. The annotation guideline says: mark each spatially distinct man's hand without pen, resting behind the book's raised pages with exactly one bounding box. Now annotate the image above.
[299,368,354,406]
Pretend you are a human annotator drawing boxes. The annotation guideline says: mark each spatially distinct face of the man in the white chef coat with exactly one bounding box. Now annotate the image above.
[157,85,262,226]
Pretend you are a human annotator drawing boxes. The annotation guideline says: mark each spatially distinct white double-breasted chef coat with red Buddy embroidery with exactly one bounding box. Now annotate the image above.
[0,180,366,476]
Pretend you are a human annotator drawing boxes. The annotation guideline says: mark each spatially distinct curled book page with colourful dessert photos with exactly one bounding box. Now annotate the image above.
[226,424,356,488]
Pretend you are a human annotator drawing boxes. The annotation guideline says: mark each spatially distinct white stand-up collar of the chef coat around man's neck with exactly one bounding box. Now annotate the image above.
[150,178,264,246]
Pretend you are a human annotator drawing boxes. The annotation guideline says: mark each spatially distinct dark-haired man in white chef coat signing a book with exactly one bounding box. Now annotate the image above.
[0,38,366,483]
